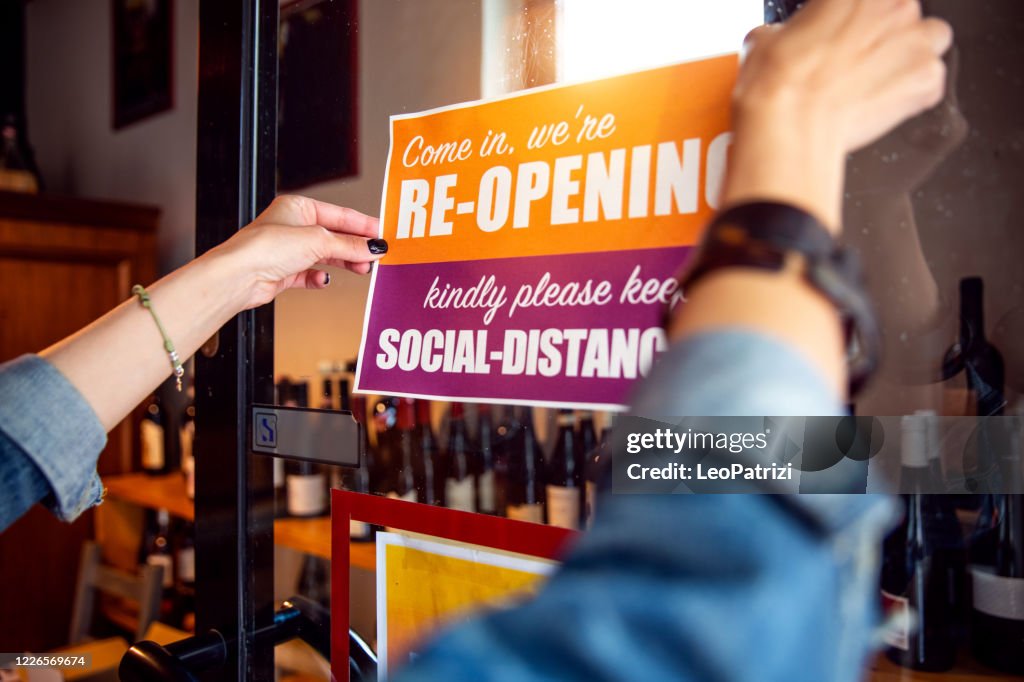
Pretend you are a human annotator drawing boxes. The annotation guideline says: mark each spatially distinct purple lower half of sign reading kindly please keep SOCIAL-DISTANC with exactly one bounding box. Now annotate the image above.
[357,247,693,407]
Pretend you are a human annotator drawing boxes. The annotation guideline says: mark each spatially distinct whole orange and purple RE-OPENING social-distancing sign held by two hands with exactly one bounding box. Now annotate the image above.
[356,55,737,409]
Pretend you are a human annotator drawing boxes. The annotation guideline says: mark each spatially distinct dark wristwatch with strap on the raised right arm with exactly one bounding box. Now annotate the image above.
[680,202,882,396]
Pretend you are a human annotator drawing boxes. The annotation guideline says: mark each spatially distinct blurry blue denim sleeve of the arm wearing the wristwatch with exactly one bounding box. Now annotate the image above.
[397,330,891,682]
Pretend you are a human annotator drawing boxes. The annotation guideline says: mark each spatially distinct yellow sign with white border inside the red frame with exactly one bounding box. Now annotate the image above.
[377,532,557,680]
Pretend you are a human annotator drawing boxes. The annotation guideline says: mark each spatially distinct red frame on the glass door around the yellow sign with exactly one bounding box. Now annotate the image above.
[331,489,577,680]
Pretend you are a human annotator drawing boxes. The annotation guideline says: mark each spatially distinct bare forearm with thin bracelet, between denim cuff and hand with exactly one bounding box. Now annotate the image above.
[40,249,246,430]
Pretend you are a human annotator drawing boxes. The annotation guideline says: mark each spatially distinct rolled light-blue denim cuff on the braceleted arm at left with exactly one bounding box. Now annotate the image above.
[0,355,106,528]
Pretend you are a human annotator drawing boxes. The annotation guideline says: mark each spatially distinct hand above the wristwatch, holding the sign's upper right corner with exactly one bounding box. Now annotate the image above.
[723,0,952,229]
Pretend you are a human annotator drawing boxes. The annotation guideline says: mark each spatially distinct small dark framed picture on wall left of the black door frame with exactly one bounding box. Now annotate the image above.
[111,0,174,129]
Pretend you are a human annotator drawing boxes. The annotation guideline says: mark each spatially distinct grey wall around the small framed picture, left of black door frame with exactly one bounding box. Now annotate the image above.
[26,0,199,271]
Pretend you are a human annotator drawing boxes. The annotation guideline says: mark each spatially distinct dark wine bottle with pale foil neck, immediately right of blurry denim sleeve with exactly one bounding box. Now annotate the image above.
[882,417,958,671]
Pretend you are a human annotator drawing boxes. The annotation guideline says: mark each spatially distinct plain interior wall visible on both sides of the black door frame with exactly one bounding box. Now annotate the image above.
[27,0,483,377]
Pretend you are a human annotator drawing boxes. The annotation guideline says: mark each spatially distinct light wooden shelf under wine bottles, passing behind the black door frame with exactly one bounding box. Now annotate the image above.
[103,473,377,570]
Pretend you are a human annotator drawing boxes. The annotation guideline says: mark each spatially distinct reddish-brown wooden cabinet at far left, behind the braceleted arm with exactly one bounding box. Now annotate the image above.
[0,193,159,651]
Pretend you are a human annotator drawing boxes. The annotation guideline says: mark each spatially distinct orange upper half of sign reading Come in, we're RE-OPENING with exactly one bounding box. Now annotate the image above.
[382,55,738,265]
